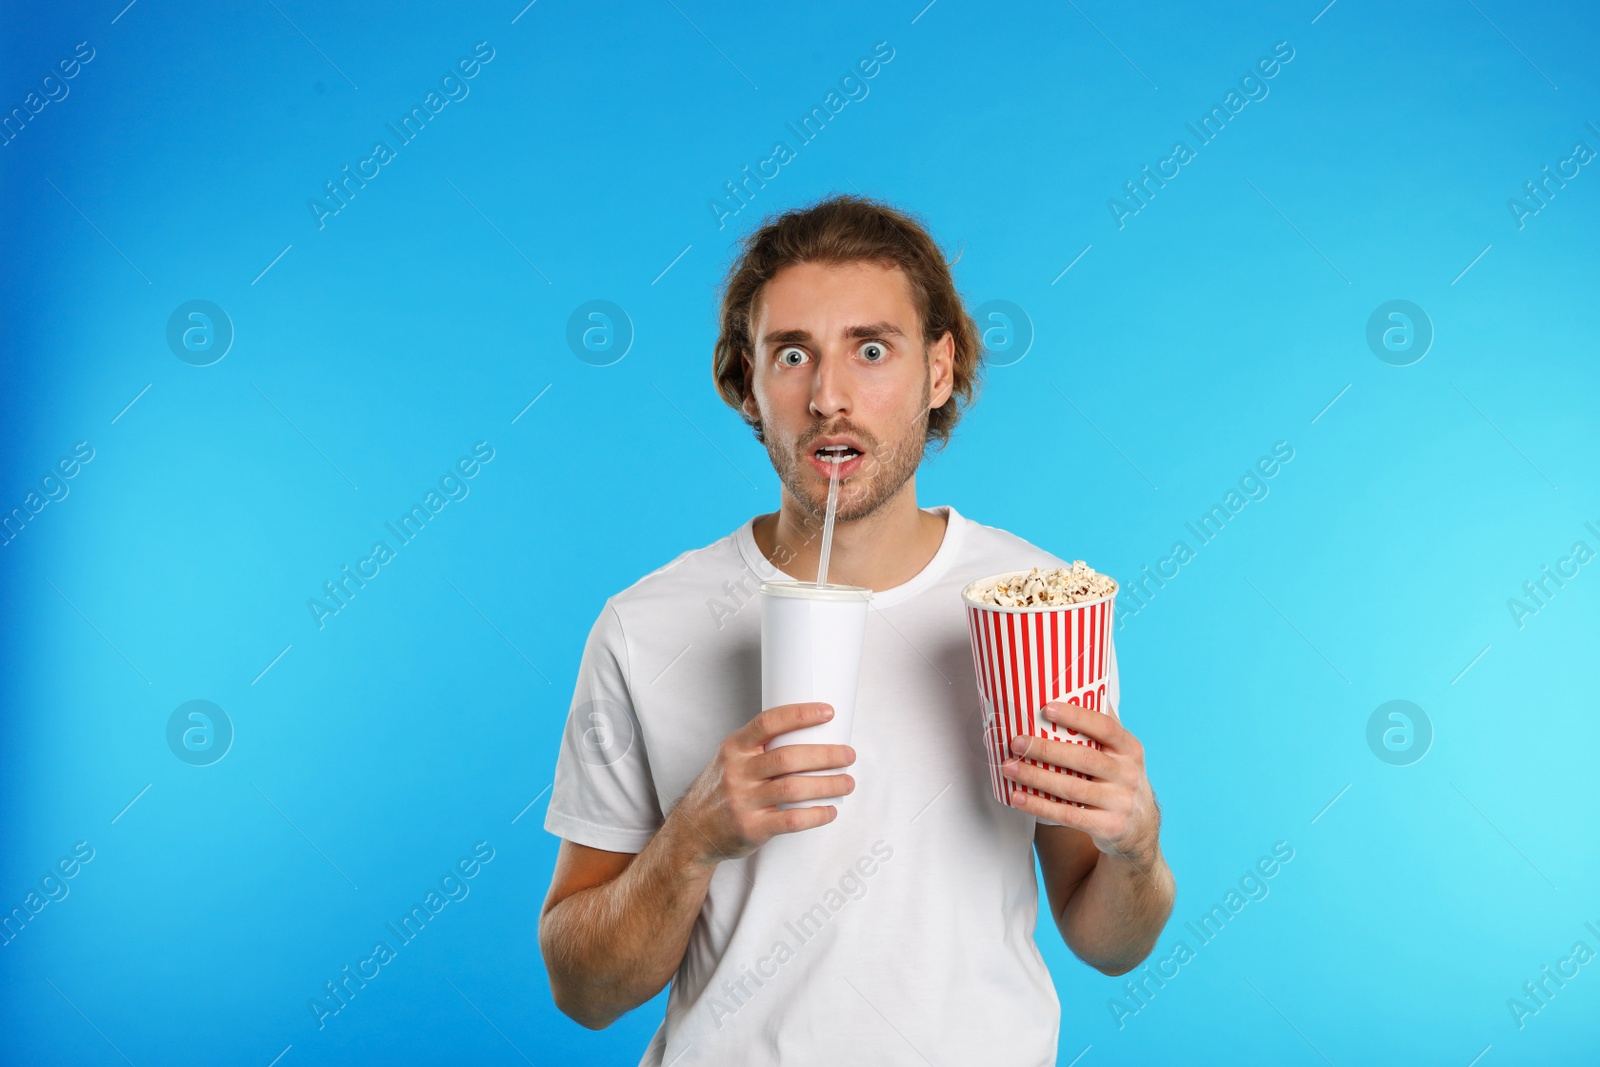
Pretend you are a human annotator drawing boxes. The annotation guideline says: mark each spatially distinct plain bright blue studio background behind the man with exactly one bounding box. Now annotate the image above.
[0,0,1600,1067]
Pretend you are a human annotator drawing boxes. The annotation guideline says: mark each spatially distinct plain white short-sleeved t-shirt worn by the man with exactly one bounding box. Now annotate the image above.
[544,507,1118,1067]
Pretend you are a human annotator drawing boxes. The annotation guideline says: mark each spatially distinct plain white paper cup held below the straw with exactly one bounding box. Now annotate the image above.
[762,582,872,808]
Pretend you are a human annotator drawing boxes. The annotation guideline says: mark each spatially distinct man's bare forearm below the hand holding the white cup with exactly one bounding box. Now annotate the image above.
[539,814,715,1030]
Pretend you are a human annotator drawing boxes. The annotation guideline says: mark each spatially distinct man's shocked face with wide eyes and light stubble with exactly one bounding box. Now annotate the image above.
[746,262,954,522]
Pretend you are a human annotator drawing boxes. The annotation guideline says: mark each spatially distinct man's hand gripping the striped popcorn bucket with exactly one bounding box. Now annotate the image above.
[1002,701,1160,867]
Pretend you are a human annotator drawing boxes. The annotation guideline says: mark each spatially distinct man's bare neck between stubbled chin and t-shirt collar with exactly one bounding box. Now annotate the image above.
[752,477,946,592]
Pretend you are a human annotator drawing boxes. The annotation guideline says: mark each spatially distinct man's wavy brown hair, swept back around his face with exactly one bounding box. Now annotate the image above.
[712,195,982,448]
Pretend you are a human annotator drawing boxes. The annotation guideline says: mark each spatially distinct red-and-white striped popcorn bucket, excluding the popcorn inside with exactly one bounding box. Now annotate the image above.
[962,571,1117,808]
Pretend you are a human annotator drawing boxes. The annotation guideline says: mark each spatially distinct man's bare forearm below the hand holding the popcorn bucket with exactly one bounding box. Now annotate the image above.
[1056,848,1176,974]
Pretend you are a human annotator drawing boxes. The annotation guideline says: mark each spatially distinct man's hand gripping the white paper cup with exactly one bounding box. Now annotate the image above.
[670,704,856,865]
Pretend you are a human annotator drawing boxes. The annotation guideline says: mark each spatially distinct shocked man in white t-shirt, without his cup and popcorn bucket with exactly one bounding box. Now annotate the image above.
[539,197,1174,1067]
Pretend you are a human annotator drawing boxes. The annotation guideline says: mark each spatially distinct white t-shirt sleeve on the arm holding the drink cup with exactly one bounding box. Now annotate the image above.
[544,600,662,853]
